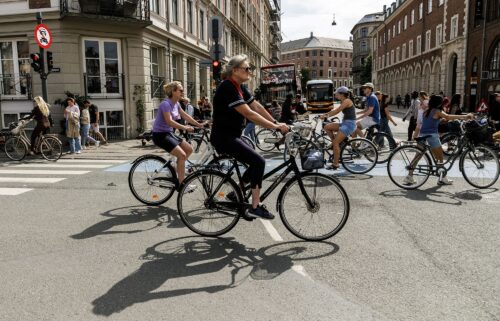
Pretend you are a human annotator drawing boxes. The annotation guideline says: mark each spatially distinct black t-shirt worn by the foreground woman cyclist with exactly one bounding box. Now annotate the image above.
[212,80,255,137]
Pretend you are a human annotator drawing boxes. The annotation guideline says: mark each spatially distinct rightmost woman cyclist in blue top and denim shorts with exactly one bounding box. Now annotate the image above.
[404,95,474,185]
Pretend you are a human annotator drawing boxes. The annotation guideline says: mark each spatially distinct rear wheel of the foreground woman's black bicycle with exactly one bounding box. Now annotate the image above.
[177,170,243,236]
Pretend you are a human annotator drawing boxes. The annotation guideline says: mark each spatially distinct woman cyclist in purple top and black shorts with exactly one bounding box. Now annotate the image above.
[153,81,203,183]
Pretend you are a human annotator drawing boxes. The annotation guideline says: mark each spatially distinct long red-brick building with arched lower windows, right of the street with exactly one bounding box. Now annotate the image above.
[372,0,469,101]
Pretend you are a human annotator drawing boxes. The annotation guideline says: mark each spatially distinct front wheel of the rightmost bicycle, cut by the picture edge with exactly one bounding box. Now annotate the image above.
[460,145,500,188]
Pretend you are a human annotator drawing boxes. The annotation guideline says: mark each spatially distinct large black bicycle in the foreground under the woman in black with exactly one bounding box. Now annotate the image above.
[177,132,350,241]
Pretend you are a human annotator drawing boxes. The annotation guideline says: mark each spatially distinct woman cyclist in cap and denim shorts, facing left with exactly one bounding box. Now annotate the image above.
[320,86,356,169]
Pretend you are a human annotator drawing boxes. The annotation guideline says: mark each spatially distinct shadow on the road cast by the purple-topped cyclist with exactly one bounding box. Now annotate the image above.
[70,206,184,240]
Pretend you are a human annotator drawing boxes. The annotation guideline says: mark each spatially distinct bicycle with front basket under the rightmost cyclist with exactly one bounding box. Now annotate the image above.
[387,121,500,189]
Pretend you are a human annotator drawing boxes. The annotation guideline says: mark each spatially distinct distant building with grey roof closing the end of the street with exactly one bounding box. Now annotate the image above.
[280,32,352,88]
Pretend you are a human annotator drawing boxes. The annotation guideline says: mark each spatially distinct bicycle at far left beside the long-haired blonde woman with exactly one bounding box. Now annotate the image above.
[4,119,62,161]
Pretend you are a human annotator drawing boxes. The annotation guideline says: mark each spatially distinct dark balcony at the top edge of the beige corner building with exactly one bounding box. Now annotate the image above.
[60,0,151,25]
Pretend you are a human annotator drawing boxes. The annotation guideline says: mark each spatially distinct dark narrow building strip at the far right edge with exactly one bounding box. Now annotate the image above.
[465,0,500,110]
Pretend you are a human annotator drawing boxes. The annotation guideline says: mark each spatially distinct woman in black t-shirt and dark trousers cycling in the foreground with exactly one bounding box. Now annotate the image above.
[210,55,288,219]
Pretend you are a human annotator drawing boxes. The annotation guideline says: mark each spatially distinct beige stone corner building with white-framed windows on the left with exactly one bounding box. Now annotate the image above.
[0,0,280,139]
